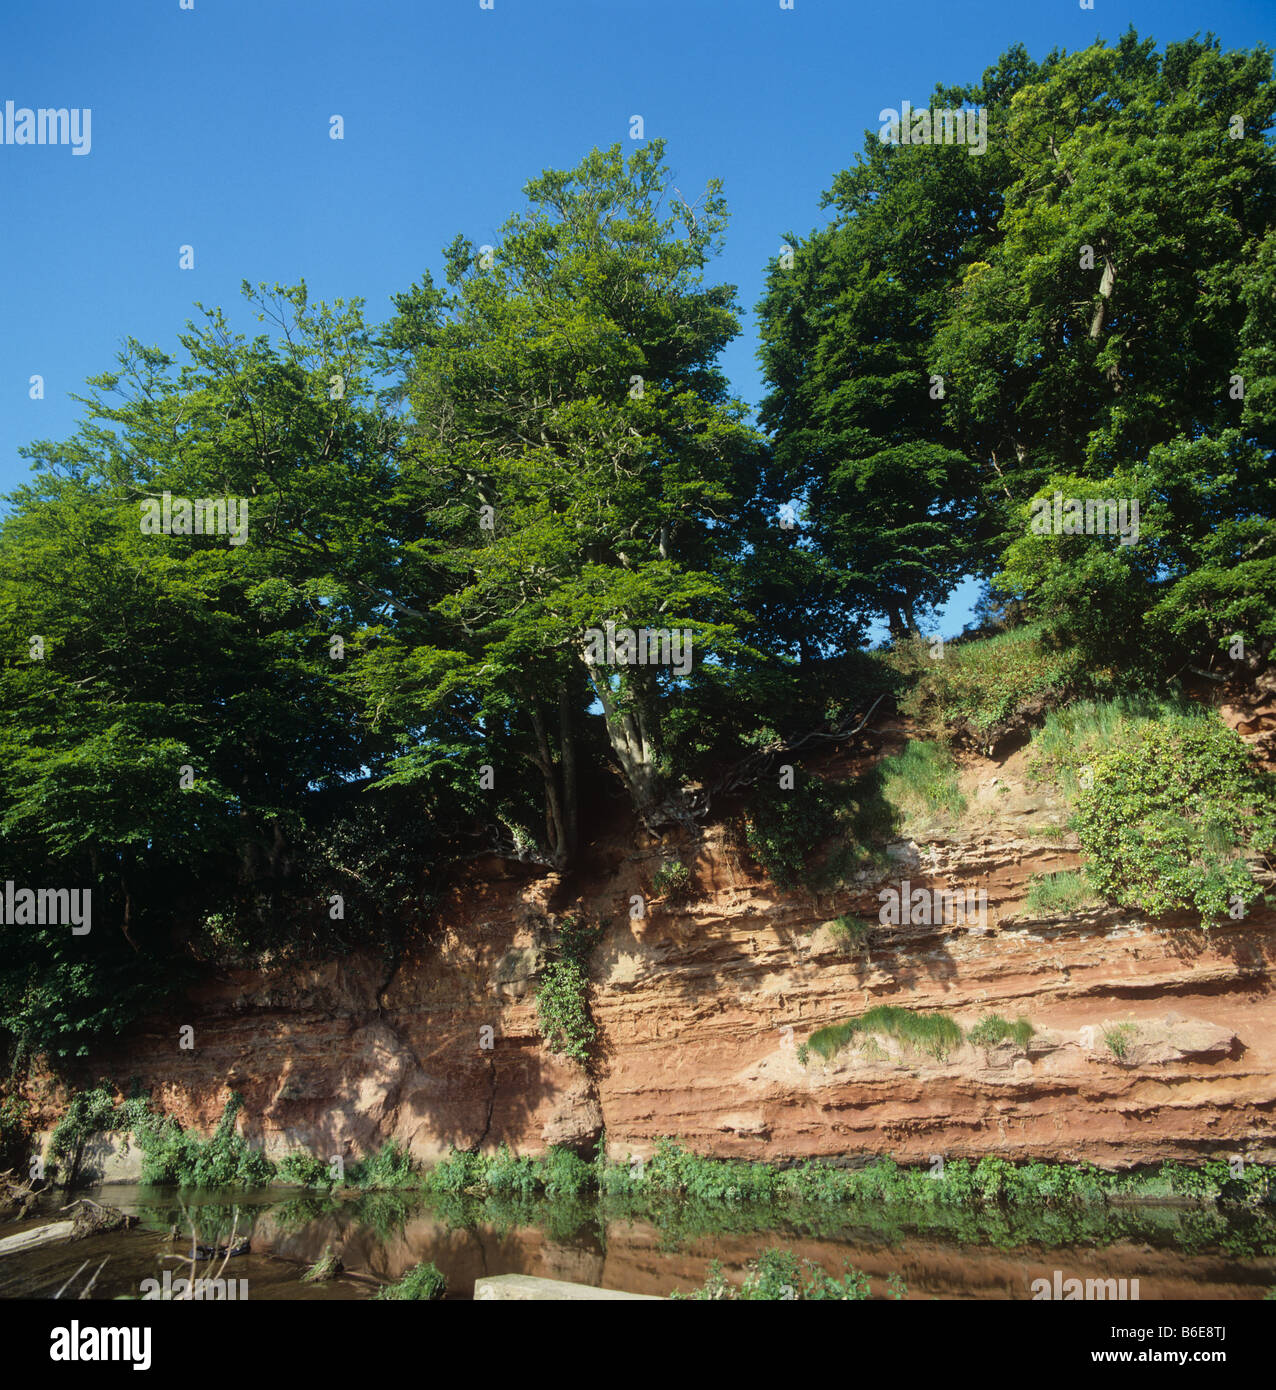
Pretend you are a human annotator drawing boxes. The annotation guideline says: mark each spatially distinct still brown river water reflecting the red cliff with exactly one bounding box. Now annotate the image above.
[0,1186,1276,1301]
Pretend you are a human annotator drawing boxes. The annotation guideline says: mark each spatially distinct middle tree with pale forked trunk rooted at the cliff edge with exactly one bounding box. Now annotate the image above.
[386,140,756,839]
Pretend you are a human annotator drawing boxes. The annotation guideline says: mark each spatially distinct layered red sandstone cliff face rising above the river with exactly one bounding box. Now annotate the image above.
[27,765,1276,1166]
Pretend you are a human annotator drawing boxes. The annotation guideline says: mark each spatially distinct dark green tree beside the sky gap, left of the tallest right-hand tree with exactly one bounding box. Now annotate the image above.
[759,49,1036,635]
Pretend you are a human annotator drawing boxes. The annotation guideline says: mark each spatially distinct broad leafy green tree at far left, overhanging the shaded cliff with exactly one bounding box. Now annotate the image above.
[0,286,444,1051]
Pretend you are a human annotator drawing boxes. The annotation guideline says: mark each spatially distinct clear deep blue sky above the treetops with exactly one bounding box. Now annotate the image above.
[0,0,1276,628]
